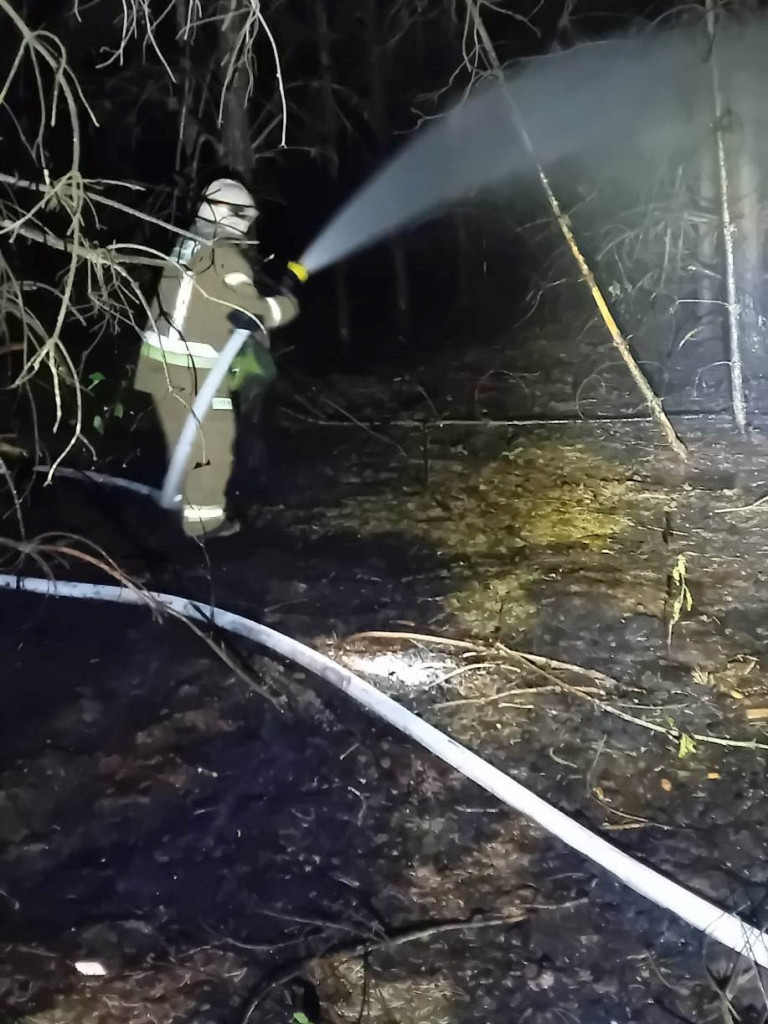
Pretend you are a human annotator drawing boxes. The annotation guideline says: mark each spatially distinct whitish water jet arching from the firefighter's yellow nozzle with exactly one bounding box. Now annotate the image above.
[302,22,768,272]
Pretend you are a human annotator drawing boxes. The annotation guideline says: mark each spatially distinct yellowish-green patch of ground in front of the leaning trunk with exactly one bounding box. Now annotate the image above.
[326,438,663,636]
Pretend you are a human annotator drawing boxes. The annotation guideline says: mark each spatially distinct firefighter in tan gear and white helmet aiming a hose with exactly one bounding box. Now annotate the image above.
[134,178,299,540]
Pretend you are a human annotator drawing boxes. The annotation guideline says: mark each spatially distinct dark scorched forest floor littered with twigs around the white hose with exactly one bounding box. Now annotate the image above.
[0,317,768,1024]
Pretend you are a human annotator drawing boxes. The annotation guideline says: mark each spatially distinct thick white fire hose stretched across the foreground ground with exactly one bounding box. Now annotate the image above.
[0,573,768,968]
